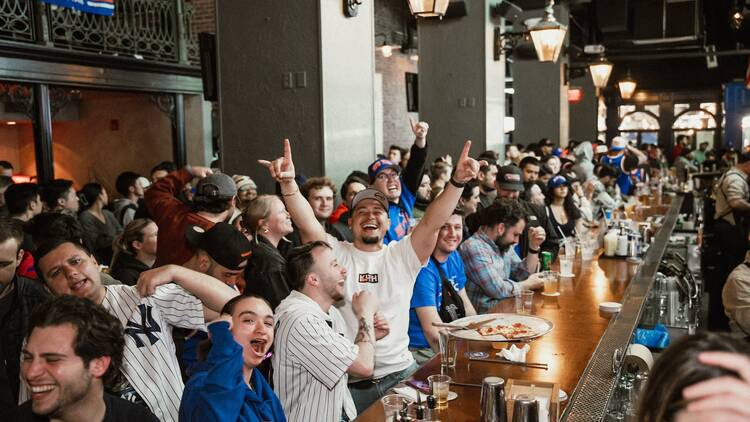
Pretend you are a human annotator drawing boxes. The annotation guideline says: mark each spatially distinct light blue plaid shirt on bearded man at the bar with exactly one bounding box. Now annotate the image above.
[459,229,529,314]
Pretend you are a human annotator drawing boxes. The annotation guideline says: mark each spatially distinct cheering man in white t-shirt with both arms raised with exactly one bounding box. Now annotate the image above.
[259,140,480,412]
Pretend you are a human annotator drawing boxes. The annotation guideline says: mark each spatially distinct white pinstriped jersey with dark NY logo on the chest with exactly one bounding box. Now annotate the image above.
[102,284,205,422]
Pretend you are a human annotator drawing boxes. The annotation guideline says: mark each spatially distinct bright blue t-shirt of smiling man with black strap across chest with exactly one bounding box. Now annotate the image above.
[409,251,466,349]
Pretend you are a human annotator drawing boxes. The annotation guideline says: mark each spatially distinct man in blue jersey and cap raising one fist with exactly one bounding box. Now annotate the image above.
[367,120,429,244]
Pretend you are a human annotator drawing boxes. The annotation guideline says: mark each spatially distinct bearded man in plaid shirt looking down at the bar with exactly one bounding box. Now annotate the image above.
[460,199,544,314]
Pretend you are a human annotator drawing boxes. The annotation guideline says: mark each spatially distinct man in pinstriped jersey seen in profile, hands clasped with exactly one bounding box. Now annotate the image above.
[273,241,388,422]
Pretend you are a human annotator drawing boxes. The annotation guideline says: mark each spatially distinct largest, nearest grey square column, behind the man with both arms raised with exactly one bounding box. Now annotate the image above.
[216,0,376,188]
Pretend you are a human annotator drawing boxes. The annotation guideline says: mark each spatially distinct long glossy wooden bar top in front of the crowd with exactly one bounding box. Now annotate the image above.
[357,198,670,422]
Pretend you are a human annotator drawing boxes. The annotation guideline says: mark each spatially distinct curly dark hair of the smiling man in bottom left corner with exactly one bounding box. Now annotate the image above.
[26,296,125,387]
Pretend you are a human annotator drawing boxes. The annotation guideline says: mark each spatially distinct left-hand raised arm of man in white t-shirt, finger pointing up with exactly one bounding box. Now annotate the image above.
[258,139,326,243]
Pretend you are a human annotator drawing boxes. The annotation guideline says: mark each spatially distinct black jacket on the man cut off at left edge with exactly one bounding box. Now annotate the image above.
[0,277,52,420]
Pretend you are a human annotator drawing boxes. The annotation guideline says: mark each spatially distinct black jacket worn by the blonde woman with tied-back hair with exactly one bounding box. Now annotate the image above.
[245,236,291,309]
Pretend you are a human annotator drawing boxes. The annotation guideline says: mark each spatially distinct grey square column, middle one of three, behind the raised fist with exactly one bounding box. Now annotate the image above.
[418,0,505,157]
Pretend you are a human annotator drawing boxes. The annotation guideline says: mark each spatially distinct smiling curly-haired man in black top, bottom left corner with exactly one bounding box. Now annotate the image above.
[14,296,158,422]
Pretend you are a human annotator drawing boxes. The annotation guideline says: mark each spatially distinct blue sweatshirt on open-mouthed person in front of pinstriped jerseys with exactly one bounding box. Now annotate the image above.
[180,322,286,422]
